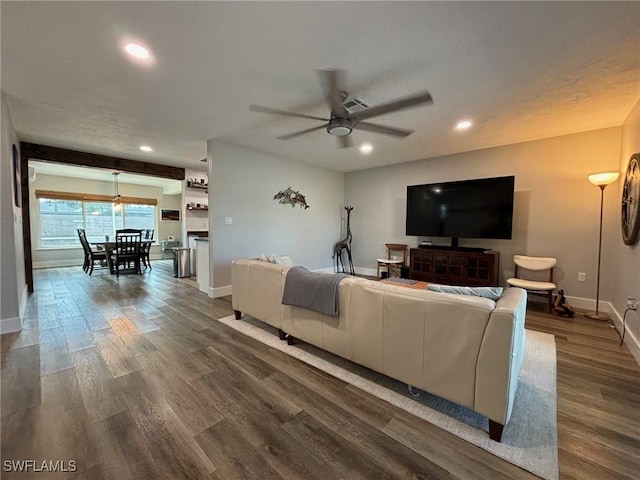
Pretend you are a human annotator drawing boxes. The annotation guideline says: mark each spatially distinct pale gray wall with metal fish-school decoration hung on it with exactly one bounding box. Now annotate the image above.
[208,140,344,288]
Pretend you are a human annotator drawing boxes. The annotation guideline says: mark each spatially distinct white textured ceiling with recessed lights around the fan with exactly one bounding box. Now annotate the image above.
[0,1,640,171]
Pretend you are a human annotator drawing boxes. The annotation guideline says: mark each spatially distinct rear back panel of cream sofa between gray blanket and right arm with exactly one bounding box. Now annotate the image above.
[348,281,496,408]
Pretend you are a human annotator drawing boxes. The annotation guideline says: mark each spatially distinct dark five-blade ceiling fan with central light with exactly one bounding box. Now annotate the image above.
[249,70,433,148]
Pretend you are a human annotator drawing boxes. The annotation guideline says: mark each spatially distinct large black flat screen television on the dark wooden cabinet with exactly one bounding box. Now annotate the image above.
[406,176,515,247]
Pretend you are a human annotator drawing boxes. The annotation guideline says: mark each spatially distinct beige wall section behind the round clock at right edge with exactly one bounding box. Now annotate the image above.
[605,100,640,363]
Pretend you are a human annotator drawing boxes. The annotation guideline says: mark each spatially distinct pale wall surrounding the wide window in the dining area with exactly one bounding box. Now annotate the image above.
[29,174,182,268]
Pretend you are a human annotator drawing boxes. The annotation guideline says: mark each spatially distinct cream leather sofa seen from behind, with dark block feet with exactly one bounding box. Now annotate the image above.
[231,259,527,441]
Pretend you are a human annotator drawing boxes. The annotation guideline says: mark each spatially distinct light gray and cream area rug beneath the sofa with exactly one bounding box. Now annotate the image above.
[219,315,558,480]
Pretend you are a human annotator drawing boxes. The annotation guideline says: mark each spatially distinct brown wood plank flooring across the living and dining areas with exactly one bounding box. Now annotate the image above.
[0,261,640,480]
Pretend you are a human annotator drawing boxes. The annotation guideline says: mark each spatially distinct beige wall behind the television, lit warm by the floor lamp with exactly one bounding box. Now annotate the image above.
[345,127,621,305]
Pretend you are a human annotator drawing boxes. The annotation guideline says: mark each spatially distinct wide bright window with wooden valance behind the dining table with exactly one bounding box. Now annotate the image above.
[36,191,156,248]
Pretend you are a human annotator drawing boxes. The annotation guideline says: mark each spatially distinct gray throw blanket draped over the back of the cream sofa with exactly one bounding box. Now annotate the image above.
[282,267,348,317]
